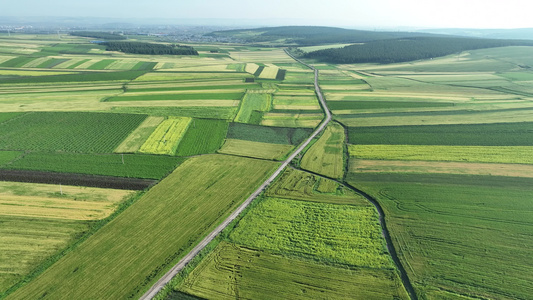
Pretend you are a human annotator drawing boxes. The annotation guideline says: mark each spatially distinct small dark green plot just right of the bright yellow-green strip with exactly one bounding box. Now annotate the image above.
[176,119,228,156]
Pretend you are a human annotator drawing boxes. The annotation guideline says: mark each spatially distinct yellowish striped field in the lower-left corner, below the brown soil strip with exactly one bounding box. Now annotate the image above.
[0,182,132,295]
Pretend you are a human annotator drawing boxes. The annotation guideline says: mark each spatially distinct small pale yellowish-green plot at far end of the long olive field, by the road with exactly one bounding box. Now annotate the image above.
[218,139,294,160]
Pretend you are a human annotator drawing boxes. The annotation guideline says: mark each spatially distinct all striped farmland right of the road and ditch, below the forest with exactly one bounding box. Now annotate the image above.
[326,47,533,299]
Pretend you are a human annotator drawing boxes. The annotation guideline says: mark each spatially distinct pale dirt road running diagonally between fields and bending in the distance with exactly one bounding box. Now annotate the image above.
[139,50,331,300]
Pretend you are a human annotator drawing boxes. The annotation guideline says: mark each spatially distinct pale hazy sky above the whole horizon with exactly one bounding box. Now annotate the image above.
[4,0,533,28]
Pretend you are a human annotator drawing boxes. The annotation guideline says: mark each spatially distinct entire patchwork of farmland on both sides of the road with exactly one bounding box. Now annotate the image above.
[4,29,533,299]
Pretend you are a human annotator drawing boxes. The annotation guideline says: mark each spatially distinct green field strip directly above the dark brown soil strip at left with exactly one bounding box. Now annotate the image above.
[1,152,184,179]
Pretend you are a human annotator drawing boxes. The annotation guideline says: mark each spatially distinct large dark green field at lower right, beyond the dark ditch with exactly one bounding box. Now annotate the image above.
[348,173,533,299]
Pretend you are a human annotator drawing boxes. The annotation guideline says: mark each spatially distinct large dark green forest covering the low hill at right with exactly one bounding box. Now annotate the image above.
[304,37,533,64]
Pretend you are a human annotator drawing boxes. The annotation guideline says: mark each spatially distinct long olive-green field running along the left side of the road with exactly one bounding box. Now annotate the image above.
[10,155,277,299]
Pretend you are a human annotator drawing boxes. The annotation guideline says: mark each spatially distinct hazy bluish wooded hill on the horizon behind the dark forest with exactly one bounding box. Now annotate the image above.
[208,26,436,46]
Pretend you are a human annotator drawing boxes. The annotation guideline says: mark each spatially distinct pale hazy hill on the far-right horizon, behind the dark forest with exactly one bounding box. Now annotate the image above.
[419,28,533,40]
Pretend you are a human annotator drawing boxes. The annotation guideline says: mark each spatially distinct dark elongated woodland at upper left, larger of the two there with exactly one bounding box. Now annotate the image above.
[102,42,198,55]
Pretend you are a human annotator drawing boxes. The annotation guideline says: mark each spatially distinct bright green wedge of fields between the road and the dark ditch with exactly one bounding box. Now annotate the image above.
[170,170,407,299]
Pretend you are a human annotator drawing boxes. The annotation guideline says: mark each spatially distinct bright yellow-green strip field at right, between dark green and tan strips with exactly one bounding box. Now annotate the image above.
[348,145,533,164]
